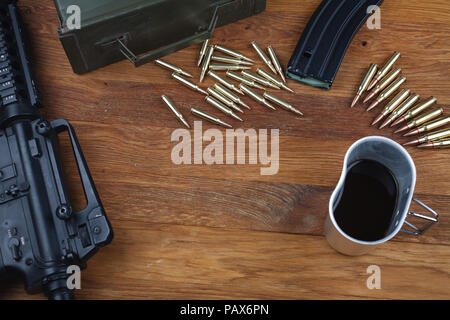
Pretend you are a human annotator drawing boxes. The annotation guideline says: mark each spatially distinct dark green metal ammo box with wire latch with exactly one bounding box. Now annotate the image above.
[54,0,266,74]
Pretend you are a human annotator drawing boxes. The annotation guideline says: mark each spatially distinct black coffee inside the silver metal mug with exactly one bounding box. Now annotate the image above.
[334,160,398,241]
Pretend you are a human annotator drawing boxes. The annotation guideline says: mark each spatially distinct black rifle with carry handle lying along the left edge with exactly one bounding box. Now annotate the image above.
[0,0,113,300]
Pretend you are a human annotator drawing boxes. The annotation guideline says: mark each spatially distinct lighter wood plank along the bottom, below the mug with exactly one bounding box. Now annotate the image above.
[0,222,450,299]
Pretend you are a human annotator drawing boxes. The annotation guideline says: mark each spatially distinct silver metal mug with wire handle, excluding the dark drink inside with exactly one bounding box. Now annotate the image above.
[325,136,439,256]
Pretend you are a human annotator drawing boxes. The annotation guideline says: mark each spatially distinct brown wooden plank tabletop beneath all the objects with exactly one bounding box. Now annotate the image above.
[0,0,450,299]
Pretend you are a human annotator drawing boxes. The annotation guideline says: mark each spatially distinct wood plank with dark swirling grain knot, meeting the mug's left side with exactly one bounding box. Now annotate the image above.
[93,177,450,245]
